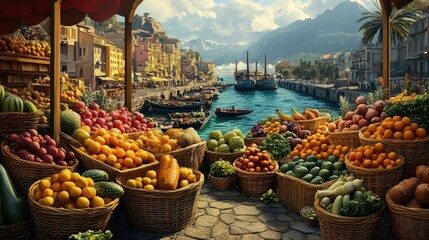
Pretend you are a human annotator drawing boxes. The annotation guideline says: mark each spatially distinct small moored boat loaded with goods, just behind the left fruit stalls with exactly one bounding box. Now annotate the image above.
[169,111,211,130]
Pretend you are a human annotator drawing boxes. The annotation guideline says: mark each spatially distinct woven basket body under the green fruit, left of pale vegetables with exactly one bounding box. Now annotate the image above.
[276,172,335,212]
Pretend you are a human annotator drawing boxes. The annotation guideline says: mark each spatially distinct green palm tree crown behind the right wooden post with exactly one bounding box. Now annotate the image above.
[358,0,420,45]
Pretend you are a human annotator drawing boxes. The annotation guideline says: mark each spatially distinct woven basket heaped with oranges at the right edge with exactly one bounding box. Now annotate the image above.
[359,116,429,178]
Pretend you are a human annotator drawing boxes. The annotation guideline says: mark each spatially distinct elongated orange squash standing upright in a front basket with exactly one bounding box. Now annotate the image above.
[158,155,180,190]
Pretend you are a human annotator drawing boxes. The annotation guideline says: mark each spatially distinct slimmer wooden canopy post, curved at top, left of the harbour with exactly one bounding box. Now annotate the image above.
[125,0,143,111]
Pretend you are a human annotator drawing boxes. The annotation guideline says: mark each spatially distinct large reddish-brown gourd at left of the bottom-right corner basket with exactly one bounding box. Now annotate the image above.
[389,178,419,205]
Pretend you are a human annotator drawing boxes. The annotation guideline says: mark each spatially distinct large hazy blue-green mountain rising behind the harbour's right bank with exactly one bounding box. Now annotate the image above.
[212,1,365,64]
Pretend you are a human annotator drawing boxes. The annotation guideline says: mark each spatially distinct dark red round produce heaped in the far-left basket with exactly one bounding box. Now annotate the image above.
[7,129,76,166]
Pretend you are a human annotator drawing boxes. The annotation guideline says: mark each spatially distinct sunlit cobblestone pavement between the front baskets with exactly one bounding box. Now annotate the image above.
[108,178,321,240]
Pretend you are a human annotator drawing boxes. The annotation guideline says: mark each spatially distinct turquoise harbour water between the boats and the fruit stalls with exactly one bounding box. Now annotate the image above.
[198,76,338,139]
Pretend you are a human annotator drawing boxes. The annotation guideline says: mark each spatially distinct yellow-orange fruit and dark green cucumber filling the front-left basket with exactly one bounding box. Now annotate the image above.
[34,169,124,209]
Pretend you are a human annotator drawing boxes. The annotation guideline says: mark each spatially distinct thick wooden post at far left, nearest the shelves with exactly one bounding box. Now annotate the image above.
[49,0,61,144]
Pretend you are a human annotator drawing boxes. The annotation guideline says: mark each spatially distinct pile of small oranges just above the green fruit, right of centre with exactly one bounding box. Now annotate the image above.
[290,125,350,162]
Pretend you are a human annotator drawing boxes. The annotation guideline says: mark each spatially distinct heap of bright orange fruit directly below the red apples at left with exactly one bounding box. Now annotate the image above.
[74,128,155,170]
